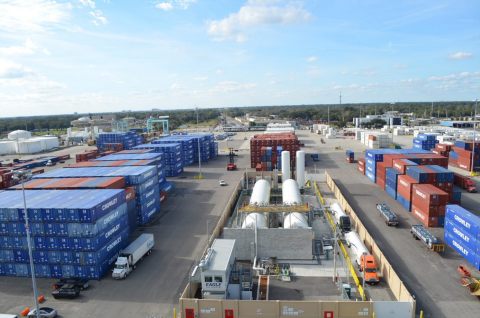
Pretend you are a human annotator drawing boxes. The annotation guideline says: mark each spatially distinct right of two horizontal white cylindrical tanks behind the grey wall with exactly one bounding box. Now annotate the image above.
[282,179,308,229]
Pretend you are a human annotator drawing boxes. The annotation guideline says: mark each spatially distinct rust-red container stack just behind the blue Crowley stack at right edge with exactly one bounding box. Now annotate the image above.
[412,184,449,227]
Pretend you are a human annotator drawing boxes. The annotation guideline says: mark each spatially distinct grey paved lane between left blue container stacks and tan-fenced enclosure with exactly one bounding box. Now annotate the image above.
[0,136,250,318]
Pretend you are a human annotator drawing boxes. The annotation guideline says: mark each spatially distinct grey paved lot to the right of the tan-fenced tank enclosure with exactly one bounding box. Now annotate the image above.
[298,131,480,318]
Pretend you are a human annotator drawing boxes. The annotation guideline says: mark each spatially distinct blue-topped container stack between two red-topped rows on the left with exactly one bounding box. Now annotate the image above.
[33,166,160,225]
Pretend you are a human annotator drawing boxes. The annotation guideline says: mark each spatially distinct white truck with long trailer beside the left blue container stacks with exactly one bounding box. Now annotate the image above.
[112,233,155,279]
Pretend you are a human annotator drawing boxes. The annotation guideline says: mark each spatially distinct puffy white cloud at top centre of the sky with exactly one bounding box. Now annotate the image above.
[207,0,310,42]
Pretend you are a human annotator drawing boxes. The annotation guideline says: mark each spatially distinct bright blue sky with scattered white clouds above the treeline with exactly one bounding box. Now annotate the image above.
[0,0,480,117]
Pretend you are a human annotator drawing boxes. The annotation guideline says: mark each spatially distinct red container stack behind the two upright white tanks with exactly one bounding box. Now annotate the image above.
[250,133,300,169]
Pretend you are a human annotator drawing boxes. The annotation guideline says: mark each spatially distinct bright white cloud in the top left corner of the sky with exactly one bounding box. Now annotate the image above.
[0,0,72,32]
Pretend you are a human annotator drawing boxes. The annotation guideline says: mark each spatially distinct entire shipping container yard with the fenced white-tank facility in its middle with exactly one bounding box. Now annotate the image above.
[0,120,479,318]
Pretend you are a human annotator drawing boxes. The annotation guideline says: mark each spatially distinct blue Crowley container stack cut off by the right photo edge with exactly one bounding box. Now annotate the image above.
[444,205,480,270]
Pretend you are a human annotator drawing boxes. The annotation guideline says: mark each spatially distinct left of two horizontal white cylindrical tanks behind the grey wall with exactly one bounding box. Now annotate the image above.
[242,179,270,229]
